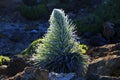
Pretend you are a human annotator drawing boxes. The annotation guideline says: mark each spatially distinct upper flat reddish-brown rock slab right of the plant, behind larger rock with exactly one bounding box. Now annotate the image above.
[86,43,120,59]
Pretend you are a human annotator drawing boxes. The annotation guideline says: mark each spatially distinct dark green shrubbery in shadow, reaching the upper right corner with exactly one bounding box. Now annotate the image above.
[73,0,120,34]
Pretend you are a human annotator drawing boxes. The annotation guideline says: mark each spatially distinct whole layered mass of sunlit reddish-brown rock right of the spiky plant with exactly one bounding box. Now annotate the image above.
[87,43,120,77]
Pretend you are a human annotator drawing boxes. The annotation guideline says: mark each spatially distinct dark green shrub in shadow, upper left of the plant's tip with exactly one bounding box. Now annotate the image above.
[19,4,49,20]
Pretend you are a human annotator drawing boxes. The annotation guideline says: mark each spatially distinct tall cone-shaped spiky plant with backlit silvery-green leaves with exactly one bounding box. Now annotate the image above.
[38,9,87,76]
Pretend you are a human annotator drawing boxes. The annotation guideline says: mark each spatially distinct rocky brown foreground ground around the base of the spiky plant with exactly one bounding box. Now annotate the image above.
[0,43,120,80]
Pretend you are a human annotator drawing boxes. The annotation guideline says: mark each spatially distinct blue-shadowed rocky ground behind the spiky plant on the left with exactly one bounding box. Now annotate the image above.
[0,8,49,55]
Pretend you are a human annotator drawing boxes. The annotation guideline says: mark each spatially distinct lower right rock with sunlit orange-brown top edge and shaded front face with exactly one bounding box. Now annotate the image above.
[88,55,120,76]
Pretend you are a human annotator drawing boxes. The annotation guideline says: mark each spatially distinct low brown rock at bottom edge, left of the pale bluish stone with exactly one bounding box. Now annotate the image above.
[6,67,49,80]
